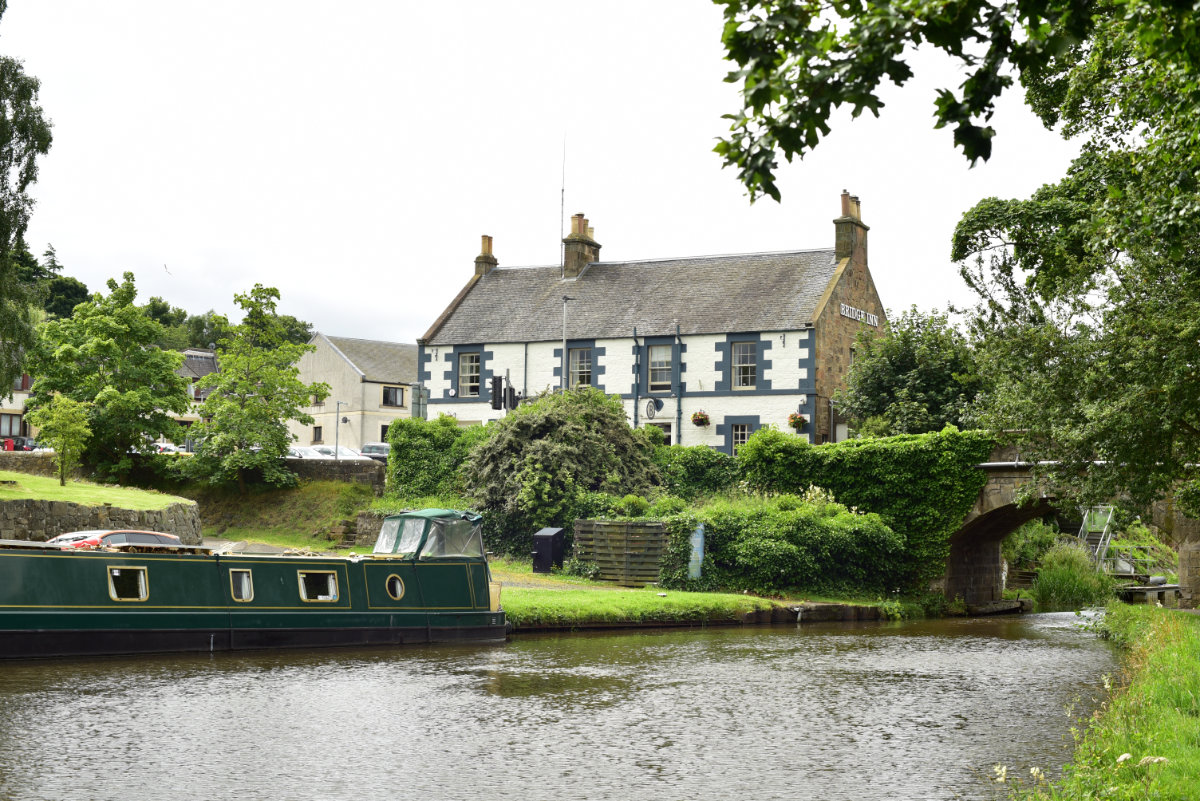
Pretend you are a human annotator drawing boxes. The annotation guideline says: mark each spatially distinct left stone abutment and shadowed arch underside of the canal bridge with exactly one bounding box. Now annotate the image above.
[944,451,1055,606]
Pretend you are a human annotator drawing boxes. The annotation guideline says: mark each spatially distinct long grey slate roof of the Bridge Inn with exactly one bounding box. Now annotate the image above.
[426,248,838,345]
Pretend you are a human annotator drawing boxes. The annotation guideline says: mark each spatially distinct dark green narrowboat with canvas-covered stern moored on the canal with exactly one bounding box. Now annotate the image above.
[0,510,505,658]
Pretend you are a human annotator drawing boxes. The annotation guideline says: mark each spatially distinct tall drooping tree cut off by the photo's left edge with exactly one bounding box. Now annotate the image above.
[0,0,50,387]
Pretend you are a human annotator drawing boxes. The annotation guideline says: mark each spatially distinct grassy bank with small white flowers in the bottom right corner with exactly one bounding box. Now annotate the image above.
[1013,603,1200,801]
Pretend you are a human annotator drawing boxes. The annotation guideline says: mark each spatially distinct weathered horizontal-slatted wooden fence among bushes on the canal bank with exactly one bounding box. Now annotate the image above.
[575,520,667,586]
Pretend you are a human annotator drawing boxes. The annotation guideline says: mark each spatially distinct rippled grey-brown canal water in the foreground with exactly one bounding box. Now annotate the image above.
[0,614,1117,801]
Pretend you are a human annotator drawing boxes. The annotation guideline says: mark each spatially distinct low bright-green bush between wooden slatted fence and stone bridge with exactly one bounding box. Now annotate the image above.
[661,496,904,594]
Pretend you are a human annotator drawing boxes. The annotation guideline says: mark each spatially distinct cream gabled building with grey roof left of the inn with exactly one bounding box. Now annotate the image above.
[288,332,416,450]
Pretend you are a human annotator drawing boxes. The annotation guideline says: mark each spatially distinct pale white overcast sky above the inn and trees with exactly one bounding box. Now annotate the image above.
[0,0,1074,342]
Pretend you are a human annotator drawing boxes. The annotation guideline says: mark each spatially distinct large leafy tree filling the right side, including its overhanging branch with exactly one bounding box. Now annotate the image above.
[718,0,1200,514]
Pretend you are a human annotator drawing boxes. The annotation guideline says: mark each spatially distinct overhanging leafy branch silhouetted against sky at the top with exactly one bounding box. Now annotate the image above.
[715,0,1104,200]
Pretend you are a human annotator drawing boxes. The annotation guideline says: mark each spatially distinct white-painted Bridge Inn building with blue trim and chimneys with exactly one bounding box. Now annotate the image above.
[418,192,886,453]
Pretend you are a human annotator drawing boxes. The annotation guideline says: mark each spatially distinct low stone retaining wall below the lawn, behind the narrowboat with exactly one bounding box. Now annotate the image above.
[0,499,200,546]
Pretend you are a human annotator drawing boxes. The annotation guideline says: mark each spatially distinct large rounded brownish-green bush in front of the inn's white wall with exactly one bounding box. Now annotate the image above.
[460,389,659,553]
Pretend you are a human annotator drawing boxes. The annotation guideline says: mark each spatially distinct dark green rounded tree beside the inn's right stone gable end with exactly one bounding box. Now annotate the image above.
[834,306,982,436]
